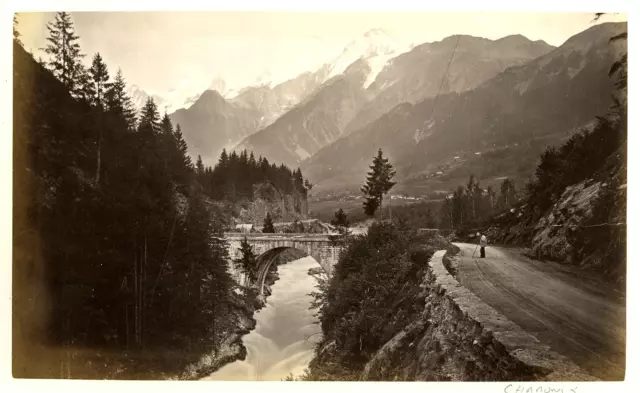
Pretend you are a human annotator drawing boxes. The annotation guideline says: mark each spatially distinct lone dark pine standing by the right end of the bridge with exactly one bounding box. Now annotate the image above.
[361,149,396,216]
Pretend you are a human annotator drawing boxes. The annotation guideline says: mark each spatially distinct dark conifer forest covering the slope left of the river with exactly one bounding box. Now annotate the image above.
[13,12,303,378]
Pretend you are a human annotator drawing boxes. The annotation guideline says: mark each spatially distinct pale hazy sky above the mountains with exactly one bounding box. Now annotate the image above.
[19,12,626,94]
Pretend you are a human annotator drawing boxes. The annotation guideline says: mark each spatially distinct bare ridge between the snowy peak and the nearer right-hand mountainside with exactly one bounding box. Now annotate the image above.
[346,35,554,133]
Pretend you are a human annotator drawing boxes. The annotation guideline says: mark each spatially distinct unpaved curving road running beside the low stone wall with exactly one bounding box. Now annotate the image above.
[456,243,626,381]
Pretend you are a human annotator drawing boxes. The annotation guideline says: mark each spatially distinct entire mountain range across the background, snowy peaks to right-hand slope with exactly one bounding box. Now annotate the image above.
[136,23,626,194]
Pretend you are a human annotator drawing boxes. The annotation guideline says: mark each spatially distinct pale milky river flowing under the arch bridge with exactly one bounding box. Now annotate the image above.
[204,257,321,381]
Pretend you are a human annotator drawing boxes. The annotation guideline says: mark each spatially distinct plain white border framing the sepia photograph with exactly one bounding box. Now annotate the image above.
[0,0,640,393]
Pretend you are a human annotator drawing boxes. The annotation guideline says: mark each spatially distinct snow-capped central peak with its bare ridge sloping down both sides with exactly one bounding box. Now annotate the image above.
[238,31,553,166]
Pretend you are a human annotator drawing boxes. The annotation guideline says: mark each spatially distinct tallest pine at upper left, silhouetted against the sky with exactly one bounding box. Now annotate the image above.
[44,12,86,97]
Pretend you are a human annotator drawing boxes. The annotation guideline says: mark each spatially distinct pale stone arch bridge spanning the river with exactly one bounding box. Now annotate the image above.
[224,232,344,296]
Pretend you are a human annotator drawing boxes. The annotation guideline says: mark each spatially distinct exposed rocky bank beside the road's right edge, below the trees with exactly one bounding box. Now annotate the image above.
[487,144,627,288]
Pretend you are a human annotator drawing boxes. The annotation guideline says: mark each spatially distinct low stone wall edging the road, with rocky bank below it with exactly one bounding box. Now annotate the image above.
[361,251,597,381]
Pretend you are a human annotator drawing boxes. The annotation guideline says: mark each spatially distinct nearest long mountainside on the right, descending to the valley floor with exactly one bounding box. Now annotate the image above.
[301,23,626,196]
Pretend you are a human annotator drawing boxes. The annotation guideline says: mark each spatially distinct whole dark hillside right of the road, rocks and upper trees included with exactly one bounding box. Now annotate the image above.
[485,67,628,284]
